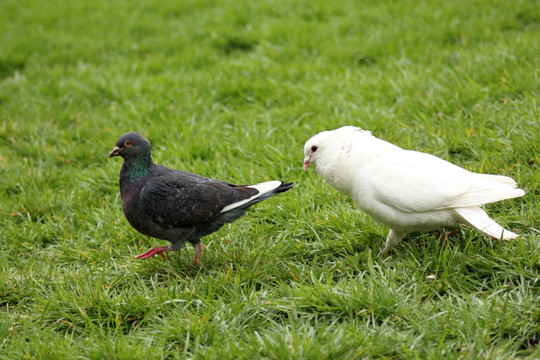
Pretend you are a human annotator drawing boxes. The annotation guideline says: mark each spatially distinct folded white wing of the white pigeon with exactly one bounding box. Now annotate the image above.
[370,150,522,212]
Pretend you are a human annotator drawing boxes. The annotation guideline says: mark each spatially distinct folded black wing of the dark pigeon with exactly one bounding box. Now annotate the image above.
[139,171,257,226]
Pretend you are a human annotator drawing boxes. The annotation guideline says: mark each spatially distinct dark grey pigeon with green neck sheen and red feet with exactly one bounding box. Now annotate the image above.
[110,132,293,262]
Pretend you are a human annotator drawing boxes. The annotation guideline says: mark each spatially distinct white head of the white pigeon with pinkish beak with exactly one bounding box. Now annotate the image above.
[304,126,369,170]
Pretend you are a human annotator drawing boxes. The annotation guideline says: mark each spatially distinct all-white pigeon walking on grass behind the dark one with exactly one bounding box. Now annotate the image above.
[304,126,525,255]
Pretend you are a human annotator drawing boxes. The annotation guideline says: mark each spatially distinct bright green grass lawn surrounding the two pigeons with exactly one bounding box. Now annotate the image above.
[0,0,540,359]
